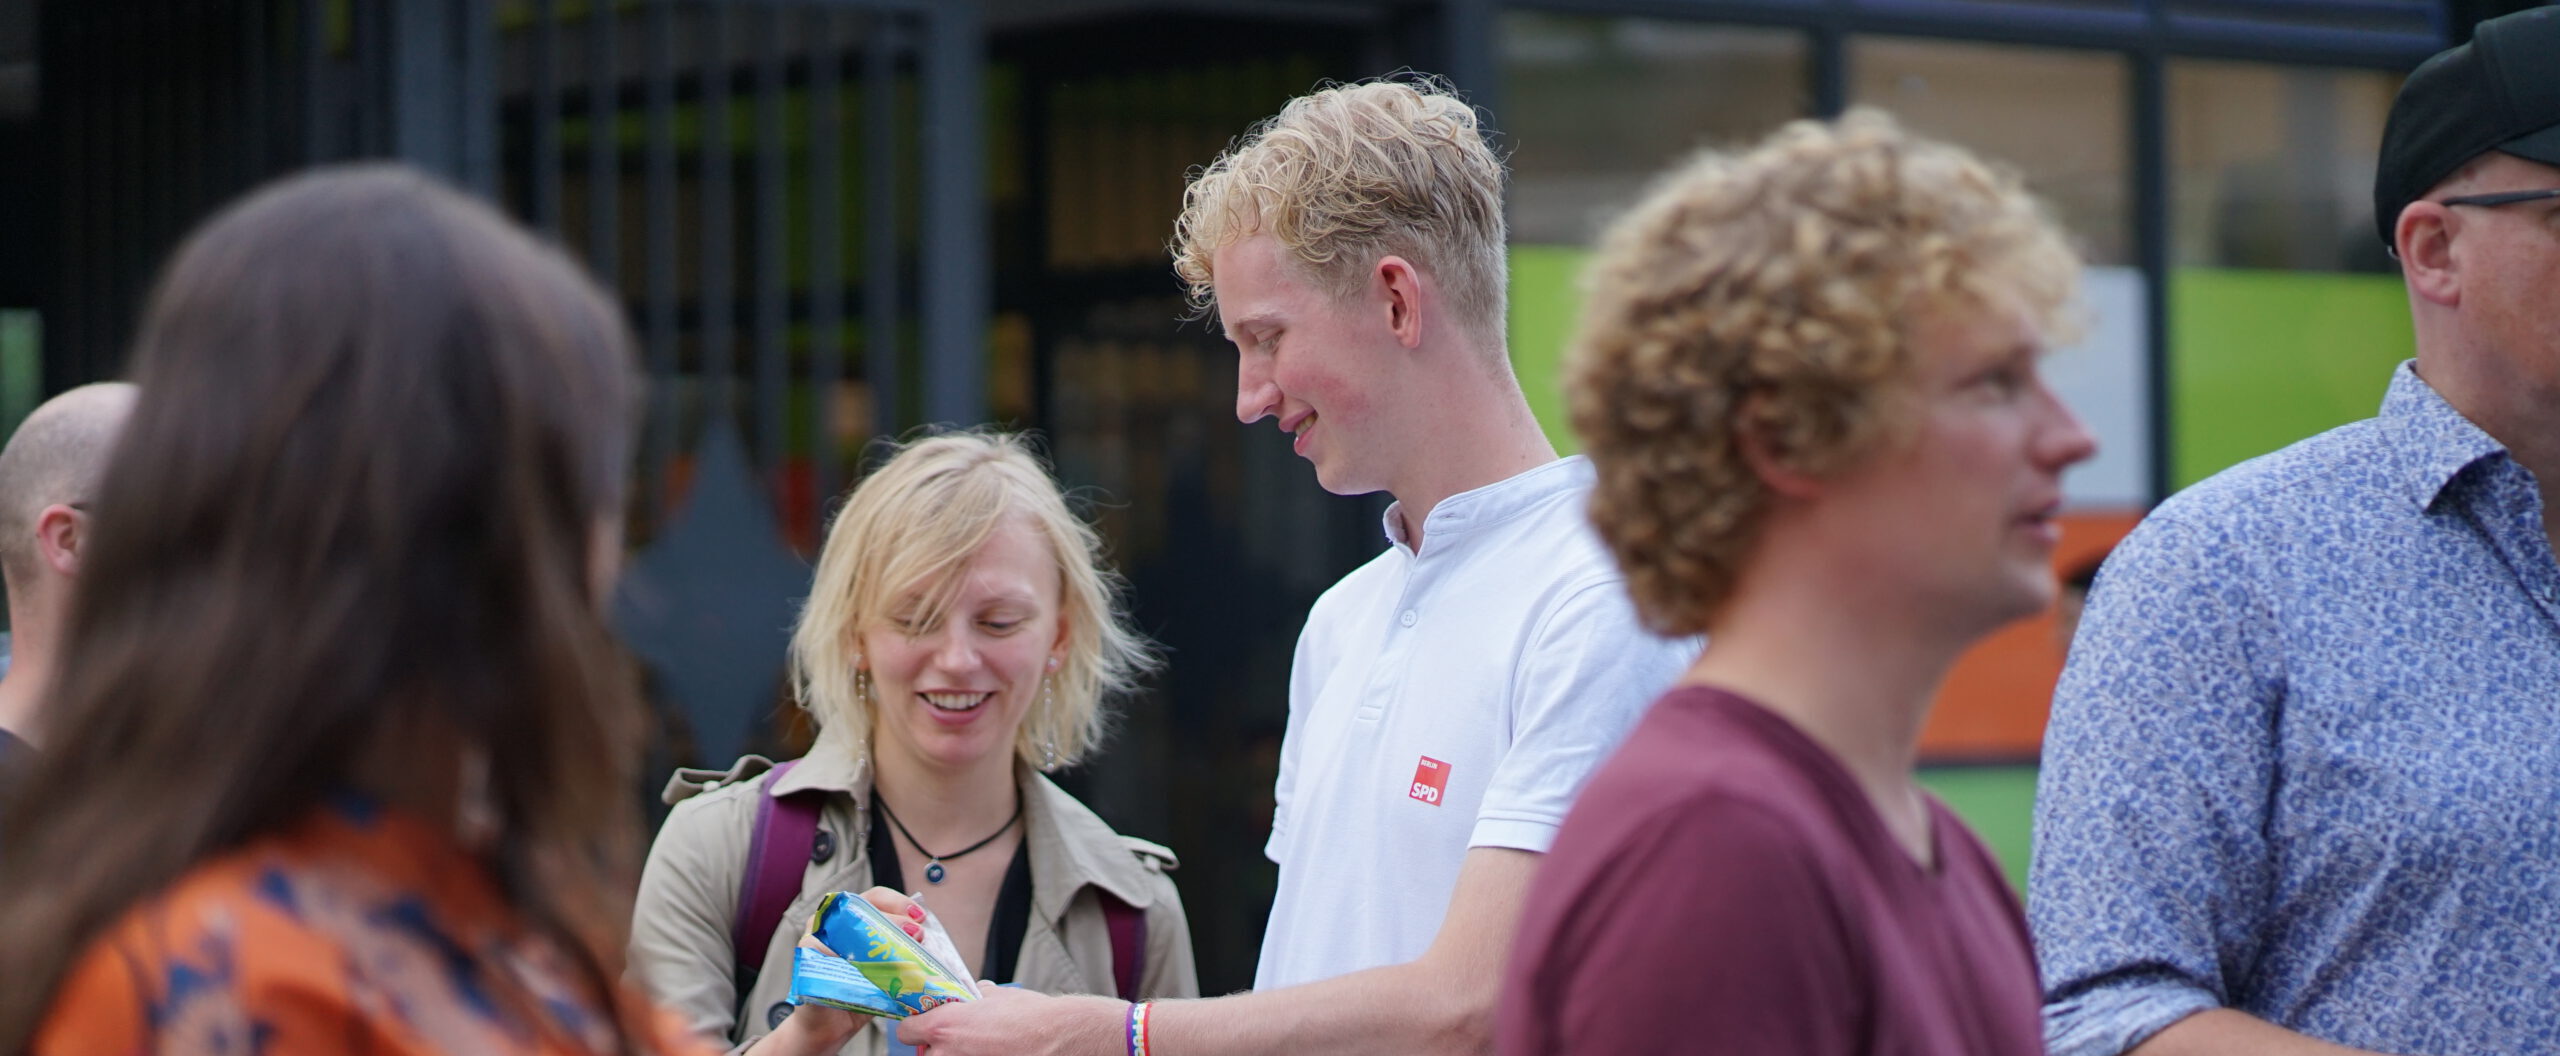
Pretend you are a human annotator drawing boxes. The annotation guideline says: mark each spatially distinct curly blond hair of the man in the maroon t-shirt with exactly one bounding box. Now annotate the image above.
[1564,110,2079,636]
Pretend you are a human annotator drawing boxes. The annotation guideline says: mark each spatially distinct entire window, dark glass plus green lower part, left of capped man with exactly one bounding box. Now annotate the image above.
[2168,62,2412,487]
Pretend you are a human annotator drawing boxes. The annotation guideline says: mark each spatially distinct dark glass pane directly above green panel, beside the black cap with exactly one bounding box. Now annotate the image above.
[2168,62,2401,272]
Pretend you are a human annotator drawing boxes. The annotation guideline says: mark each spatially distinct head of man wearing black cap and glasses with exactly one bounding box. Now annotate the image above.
[2373,8,2560,392]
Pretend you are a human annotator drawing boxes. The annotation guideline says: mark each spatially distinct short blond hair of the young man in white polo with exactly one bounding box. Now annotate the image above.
[1170,79,1510,349]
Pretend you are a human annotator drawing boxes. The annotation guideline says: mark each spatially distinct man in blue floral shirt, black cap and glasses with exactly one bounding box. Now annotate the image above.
[2028,8,2560,1056]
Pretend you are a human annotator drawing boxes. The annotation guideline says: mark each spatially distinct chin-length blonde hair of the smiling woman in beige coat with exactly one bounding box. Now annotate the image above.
[791,431,1155,769]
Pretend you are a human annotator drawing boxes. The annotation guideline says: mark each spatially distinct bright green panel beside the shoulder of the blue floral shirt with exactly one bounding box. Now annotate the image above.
[2168,267,2412,487]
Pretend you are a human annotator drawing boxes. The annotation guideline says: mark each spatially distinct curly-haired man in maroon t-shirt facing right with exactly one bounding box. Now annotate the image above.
[1500,113,2094,1056]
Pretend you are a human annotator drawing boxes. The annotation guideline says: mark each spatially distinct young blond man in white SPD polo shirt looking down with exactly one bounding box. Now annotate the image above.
[901,82,1695,1056]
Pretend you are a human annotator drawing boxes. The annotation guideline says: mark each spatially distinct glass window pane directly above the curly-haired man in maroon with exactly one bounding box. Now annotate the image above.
[1500,13,1812,246]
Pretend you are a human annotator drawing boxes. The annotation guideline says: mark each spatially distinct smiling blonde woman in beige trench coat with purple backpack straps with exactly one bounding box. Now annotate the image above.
[632,433,1198,1053]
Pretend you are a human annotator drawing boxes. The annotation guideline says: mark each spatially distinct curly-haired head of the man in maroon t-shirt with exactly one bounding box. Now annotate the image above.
[1567,113,2094,643]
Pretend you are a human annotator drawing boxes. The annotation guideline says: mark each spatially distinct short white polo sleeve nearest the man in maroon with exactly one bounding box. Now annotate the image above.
[1467,577,1700,854]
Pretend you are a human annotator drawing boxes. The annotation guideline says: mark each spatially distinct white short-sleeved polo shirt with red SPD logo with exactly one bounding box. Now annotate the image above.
[1254,456,1697,989]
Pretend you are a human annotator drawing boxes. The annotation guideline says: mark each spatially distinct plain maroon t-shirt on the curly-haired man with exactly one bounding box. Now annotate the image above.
[1498,687,2045,1056]
